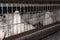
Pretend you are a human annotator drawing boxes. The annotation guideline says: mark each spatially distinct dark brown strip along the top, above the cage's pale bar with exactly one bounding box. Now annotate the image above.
[0,0,60,4]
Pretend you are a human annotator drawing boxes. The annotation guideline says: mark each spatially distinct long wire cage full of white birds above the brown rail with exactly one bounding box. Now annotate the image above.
[0,3,60,40]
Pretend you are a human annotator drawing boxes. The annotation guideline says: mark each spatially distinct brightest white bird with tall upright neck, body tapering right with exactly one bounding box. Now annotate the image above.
[14,11,34,33]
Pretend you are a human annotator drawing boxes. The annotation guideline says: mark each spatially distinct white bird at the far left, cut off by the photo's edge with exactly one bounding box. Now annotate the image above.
[0,15,6,40]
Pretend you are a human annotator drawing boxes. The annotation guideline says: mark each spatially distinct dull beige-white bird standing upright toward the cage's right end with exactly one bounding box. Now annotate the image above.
[43,11,53,25]
